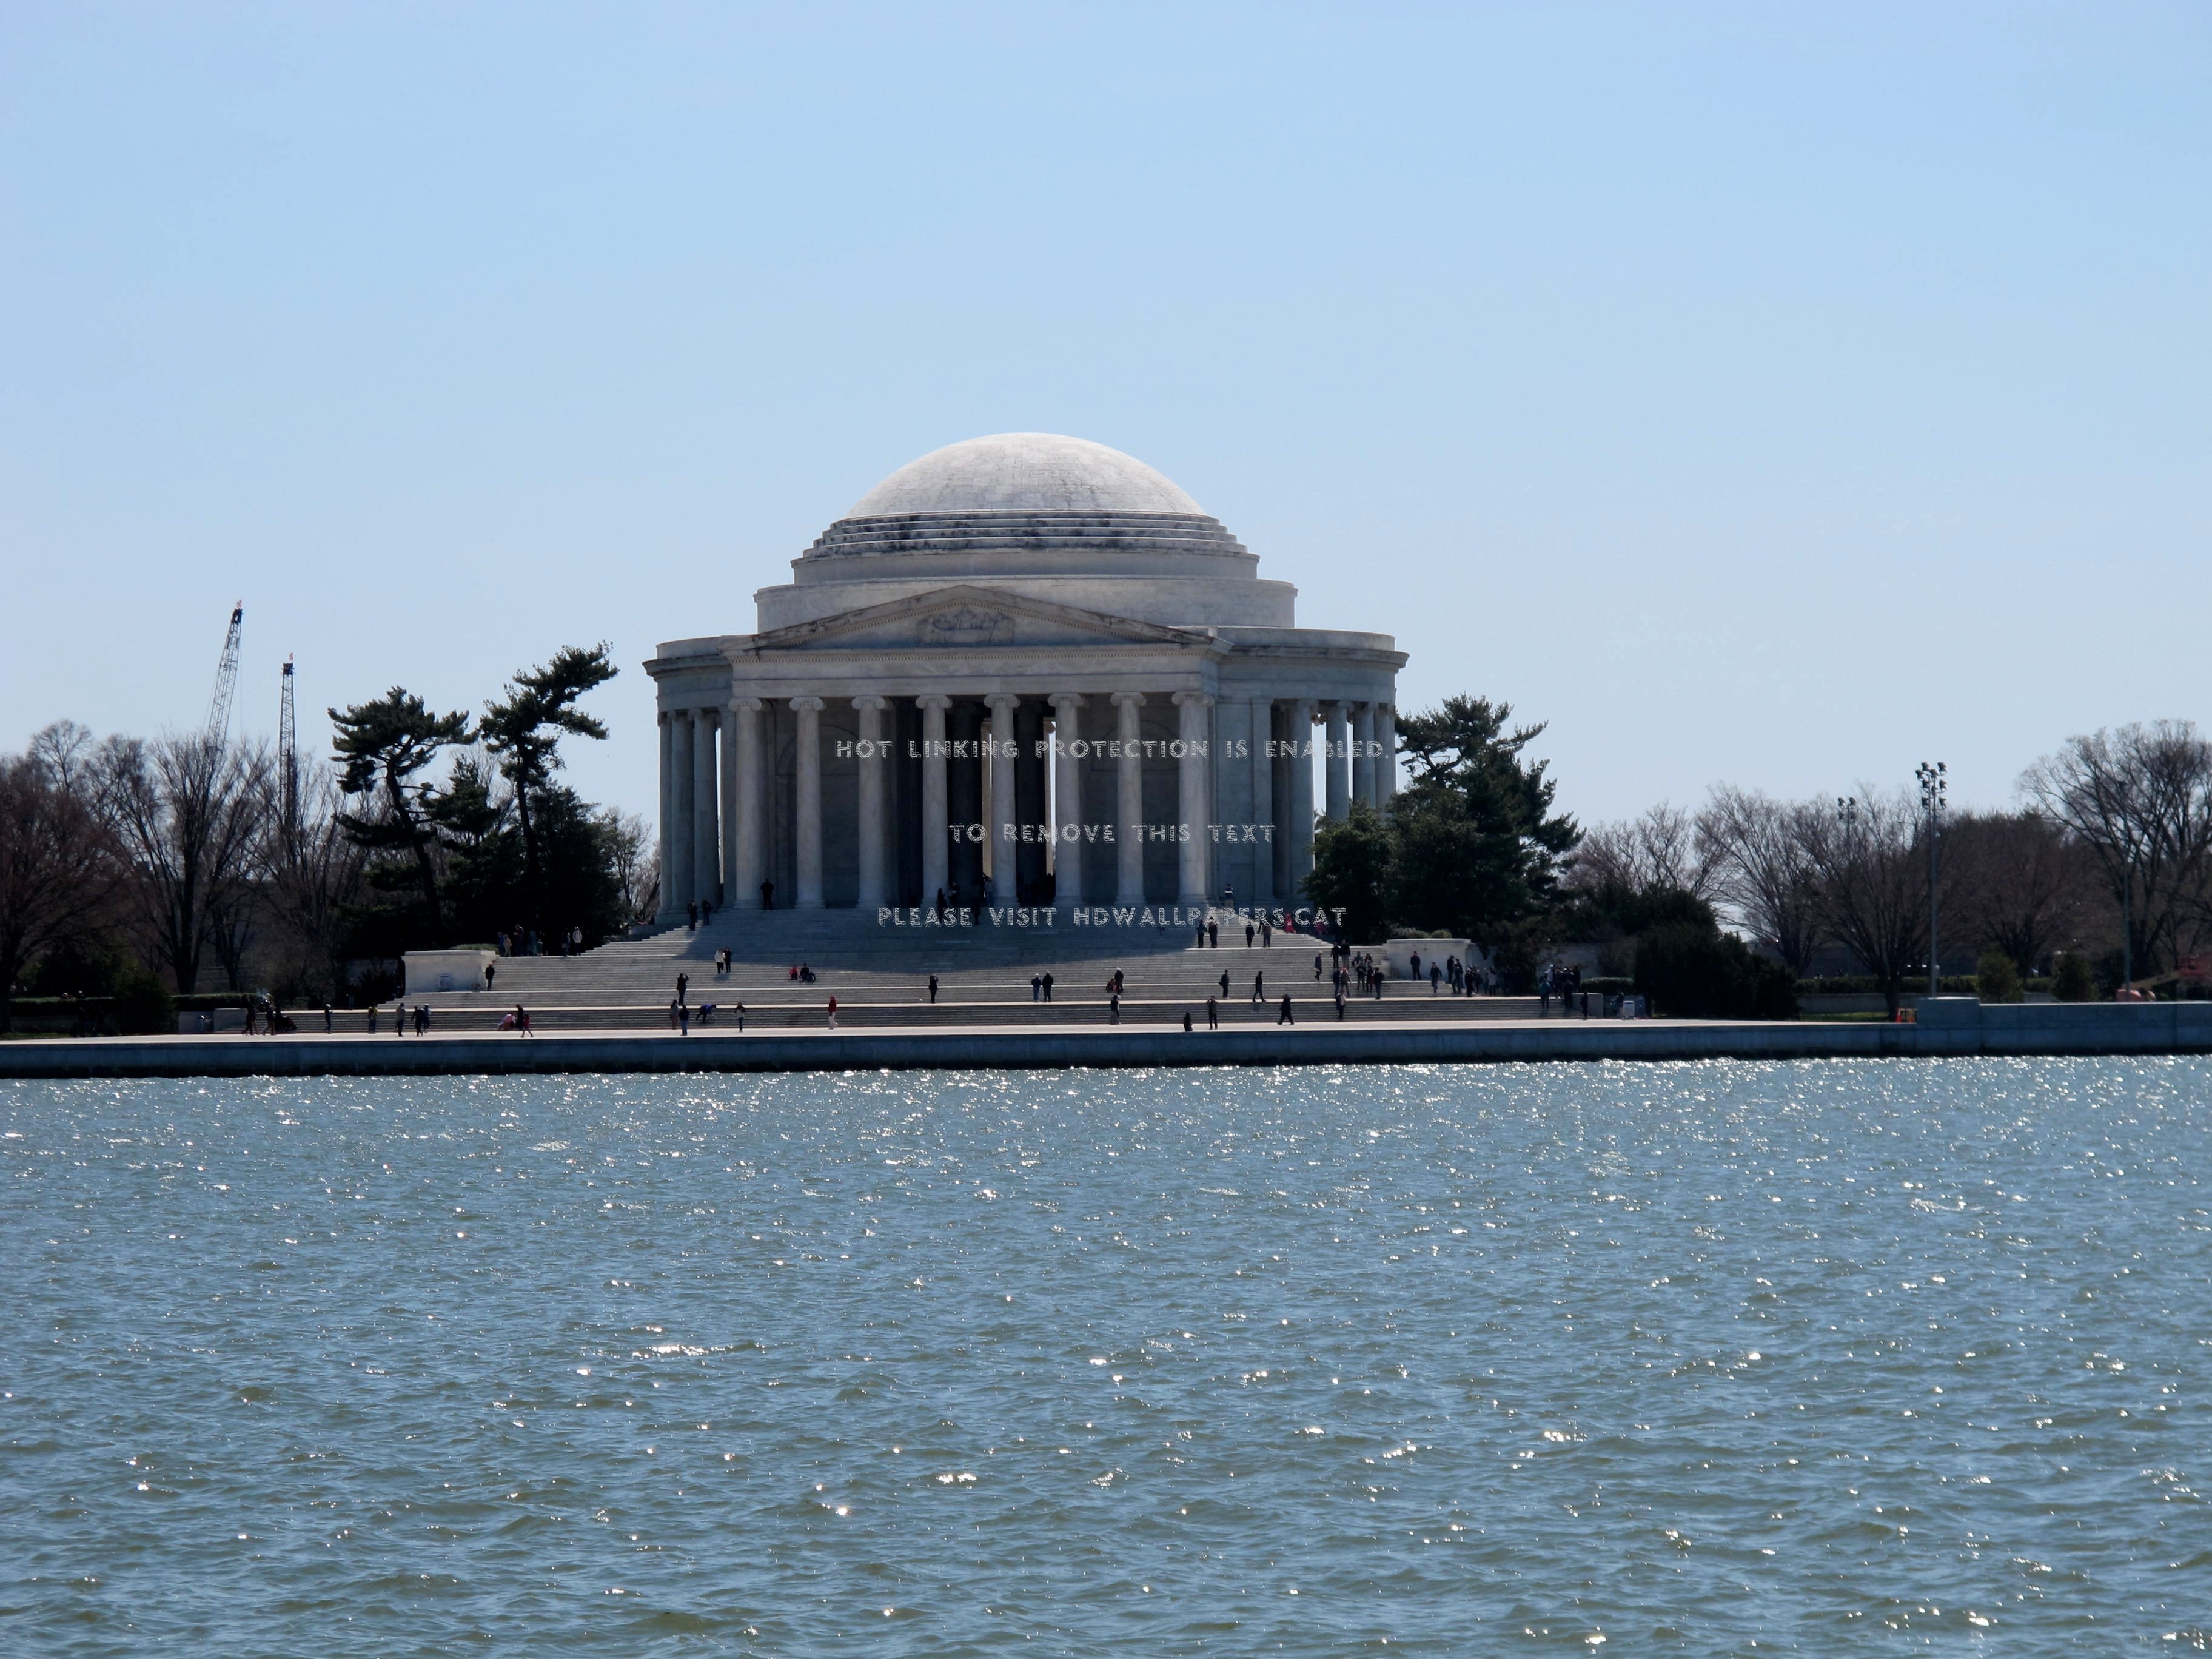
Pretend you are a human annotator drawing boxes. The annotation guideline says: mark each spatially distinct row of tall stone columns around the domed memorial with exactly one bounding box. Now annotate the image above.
[662,690,1398,918]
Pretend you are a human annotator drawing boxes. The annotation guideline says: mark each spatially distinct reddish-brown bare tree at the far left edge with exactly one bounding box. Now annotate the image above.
[0,748,115,1033]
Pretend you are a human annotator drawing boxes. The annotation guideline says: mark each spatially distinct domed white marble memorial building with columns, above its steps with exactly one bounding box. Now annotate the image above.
[646,431,1404,922]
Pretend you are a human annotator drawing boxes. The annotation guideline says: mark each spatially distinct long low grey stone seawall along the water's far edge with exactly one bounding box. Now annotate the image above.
[0,997,2212,1078]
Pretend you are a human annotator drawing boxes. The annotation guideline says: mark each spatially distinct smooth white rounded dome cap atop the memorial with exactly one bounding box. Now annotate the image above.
[845,431,1205,518]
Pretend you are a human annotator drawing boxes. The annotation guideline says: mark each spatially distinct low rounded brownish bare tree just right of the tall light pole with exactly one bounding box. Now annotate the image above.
[1942,809,2097,973]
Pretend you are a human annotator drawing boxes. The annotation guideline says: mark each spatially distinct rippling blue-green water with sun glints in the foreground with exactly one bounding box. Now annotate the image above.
[0,1059,2212,1657]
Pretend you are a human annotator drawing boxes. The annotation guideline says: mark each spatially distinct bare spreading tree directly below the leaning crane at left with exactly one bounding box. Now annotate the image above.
[95,732,270,993]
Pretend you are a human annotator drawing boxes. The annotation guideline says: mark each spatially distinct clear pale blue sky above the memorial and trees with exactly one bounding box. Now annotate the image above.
[0,0,2212,819]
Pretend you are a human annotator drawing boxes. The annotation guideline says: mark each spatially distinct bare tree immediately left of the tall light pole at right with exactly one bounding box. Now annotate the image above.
[1805,785,1929,1017]
